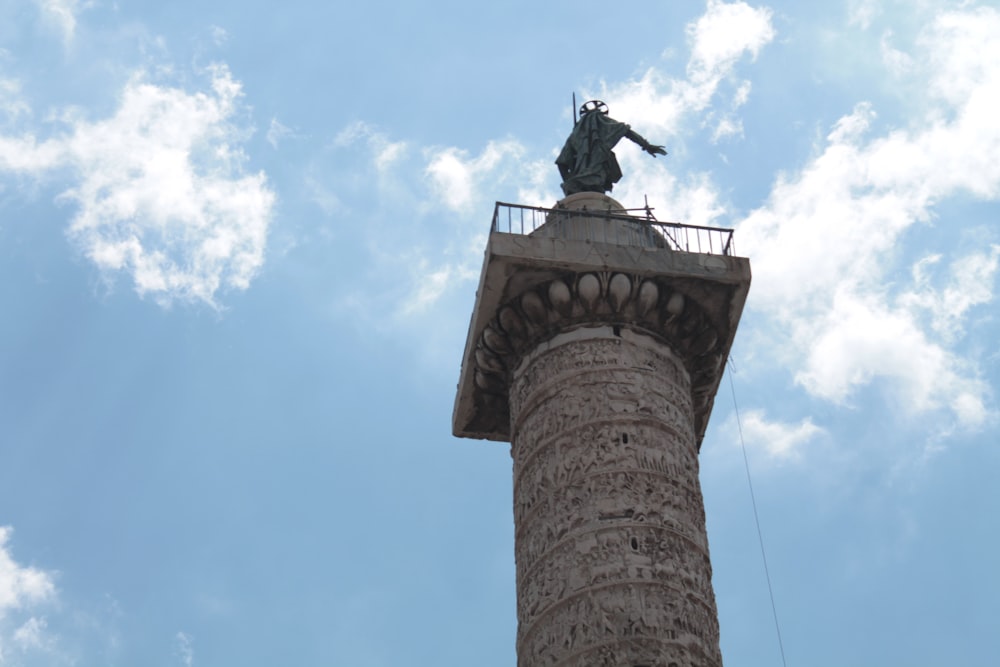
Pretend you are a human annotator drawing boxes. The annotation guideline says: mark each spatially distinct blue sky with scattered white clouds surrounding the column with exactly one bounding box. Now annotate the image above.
[0,0,1000,667]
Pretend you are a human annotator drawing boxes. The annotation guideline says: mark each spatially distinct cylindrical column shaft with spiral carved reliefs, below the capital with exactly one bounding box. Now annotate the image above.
[510,326,721,667]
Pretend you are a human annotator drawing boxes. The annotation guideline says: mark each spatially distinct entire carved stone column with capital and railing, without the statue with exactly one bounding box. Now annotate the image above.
[453,193,750,667]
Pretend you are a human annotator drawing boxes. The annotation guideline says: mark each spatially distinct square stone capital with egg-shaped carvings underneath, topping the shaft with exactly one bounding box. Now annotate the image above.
[452,214,750,446]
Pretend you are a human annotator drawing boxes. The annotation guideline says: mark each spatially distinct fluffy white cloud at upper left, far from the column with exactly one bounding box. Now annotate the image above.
[0,66,275,306]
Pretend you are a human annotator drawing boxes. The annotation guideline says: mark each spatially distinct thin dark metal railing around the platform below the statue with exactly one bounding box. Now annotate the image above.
[490,202,736,255]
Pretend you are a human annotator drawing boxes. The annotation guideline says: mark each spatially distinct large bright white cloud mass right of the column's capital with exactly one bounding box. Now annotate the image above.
[738,9,1000,426]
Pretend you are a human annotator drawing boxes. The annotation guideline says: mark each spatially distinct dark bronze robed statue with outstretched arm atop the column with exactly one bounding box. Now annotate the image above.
[556,100,667,196]
